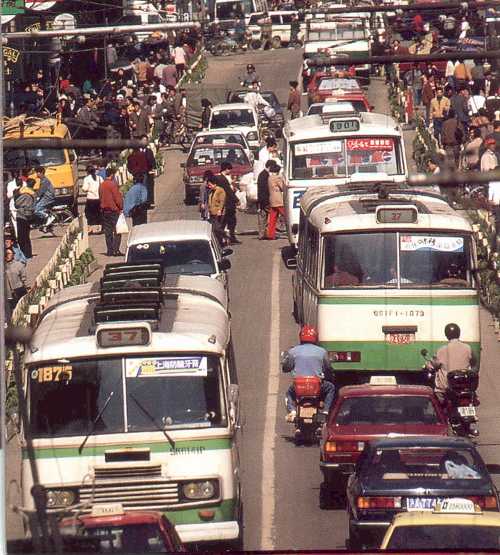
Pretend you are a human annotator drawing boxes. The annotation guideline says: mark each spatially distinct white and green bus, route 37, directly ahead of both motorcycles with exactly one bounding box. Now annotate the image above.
[293,185,480,383]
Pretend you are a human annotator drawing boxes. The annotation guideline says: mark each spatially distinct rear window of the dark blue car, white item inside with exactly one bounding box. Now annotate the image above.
[362,445,489,482]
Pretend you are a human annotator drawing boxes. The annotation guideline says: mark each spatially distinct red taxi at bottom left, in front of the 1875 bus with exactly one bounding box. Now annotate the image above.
[60,503,187,554]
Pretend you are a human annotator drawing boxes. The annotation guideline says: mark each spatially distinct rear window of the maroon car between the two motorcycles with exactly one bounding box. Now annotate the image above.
[335,395,439,426]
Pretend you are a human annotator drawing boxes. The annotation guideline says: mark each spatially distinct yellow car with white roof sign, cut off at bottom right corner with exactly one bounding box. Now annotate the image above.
[380,498,500,553]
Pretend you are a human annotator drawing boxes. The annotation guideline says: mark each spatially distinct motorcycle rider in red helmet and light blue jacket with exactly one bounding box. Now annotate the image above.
[281,325,335,422]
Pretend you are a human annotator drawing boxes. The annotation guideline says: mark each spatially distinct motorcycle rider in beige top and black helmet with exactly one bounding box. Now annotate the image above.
[433,323,477,402]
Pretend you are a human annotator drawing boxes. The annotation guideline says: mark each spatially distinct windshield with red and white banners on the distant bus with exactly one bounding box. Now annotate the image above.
[291,137,404,179]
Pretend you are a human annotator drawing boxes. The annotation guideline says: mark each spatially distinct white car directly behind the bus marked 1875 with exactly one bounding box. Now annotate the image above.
[125,220,233,284]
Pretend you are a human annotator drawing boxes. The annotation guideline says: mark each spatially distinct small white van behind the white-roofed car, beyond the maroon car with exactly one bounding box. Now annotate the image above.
[208,102,260,152]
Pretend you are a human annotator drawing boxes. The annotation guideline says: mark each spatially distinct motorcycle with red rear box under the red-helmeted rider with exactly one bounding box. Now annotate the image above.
[293,376,324,445]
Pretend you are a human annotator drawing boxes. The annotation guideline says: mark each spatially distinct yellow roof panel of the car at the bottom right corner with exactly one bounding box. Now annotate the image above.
[393,511,500,527]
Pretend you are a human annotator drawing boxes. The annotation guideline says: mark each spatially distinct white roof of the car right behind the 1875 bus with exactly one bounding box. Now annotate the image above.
[127,220,212,246]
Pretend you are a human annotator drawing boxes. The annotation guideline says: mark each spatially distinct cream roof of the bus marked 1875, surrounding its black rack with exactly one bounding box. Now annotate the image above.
[26,276,230,364]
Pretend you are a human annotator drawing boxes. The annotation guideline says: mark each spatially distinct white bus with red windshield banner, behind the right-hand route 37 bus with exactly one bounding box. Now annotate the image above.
[283,101,408,247]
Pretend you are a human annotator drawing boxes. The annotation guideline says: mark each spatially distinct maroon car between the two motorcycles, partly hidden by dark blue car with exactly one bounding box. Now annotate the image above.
[320,377,448,508]
